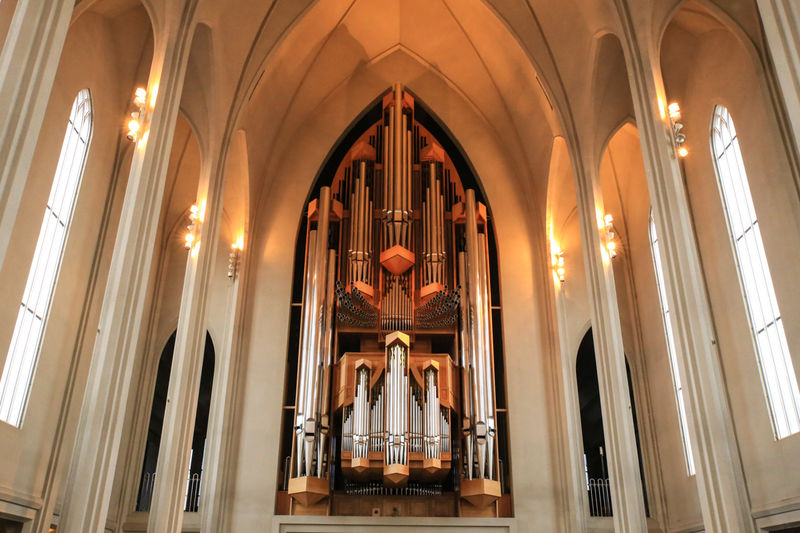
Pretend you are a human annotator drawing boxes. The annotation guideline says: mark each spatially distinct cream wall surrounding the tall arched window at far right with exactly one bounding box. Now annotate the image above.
[662,17,800,513]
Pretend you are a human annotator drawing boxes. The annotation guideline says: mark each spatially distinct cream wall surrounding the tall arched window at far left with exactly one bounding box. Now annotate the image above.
[0,8,151,520]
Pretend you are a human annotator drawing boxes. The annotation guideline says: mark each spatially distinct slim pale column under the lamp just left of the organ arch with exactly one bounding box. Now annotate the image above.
[200,233,250,532]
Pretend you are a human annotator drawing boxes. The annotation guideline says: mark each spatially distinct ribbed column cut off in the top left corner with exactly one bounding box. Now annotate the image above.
[0,0,75,265]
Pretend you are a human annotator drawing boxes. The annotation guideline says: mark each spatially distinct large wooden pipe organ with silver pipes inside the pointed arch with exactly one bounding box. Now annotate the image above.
[276,85,512,517]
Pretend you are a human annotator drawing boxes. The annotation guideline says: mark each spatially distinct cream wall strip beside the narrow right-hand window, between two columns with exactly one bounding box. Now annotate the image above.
[600,124,702,531]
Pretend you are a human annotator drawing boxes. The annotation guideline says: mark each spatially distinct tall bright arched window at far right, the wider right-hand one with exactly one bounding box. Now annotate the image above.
[711,106,800,439]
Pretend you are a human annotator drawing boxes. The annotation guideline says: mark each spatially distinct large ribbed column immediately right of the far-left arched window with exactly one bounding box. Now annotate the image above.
[59,12,193,533]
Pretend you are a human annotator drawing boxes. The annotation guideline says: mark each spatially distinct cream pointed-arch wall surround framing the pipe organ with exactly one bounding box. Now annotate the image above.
[222,48,561,531]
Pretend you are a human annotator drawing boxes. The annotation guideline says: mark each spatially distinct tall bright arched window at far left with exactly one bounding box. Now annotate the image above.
[0,89,92,426]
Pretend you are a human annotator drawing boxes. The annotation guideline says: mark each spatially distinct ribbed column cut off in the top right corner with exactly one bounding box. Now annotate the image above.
[757,0,800,166]
